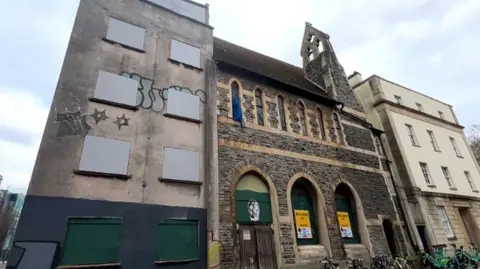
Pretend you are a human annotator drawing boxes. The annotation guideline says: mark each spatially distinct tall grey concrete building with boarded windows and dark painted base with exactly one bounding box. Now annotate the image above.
[9,0,217,269]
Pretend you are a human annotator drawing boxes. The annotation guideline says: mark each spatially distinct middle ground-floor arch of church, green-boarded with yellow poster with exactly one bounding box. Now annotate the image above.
[291,179,320,246]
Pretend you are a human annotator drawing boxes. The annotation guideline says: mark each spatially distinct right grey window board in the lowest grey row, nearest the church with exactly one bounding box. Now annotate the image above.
[162,147,200,182]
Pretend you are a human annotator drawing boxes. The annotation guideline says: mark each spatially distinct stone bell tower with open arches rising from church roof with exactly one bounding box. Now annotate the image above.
[300,22,363,112]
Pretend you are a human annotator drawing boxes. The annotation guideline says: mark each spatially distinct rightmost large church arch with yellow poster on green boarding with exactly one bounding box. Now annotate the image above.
[335,183,360,244]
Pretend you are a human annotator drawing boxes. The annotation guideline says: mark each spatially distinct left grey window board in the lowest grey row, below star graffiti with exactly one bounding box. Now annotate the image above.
[78,135,130,175]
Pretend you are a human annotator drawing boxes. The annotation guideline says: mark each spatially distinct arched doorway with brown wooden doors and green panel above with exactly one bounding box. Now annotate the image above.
[235,173,277,269]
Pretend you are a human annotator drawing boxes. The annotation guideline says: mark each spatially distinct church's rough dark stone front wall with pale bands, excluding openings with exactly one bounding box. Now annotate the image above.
[217,70,396,268]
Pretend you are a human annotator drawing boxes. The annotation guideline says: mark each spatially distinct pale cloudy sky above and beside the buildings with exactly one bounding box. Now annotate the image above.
[0,0,480,191]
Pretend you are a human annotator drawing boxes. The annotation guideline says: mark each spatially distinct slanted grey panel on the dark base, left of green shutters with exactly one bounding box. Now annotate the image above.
[7,241,60,269]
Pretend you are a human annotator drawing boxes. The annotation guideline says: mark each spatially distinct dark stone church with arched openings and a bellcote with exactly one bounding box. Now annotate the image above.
[213,23,408,268]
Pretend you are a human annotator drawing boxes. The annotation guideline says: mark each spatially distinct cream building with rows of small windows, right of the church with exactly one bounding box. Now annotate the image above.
[349,73,480,249]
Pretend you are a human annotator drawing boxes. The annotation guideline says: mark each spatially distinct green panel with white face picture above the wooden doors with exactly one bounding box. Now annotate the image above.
[235,190,273,224]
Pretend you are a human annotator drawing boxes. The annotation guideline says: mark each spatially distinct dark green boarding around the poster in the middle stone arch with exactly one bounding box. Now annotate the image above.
[292,183,319,245]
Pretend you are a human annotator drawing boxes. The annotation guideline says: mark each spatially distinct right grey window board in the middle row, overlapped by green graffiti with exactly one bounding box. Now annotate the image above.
[167,89,200,120]
